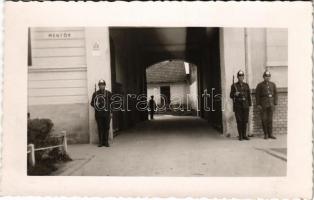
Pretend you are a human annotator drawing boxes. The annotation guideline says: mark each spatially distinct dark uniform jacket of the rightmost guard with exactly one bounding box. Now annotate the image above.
[255,81,278,108]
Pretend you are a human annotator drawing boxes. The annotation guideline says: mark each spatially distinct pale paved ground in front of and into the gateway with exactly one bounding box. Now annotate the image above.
[56,115,287,176]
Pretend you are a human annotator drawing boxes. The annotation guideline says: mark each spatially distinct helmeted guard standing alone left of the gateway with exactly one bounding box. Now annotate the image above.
[90,80,111,147]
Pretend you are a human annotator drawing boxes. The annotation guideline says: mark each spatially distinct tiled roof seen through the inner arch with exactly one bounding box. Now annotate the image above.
[146,60,187,83]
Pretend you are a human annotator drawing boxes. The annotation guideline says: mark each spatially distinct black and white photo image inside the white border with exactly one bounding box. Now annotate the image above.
[27,27,289,177]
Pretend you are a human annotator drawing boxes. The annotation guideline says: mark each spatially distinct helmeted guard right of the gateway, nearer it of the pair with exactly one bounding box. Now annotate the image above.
[230,70,252,140]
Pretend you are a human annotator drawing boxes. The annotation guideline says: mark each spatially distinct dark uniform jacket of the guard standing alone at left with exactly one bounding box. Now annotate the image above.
[90,90,112,117]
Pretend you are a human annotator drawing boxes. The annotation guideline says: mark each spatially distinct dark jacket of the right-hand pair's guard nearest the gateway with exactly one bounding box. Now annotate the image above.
[230,82,252,111]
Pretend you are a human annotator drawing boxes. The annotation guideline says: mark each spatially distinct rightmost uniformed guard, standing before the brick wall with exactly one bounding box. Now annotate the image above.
[256,70,278,139]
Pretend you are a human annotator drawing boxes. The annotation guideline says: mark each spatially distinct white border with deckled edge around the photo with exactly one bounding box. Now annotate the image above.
[1,2,312,198]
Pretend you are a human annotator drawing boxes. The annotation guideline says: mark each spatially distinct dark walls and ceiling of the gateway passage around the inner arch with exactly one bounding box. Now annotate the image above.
[109,27,222,136]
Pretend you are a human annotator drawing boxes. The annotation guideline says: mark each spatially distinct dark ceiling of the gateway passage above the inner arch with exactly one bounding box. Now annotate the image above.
[110,27,216,67]
